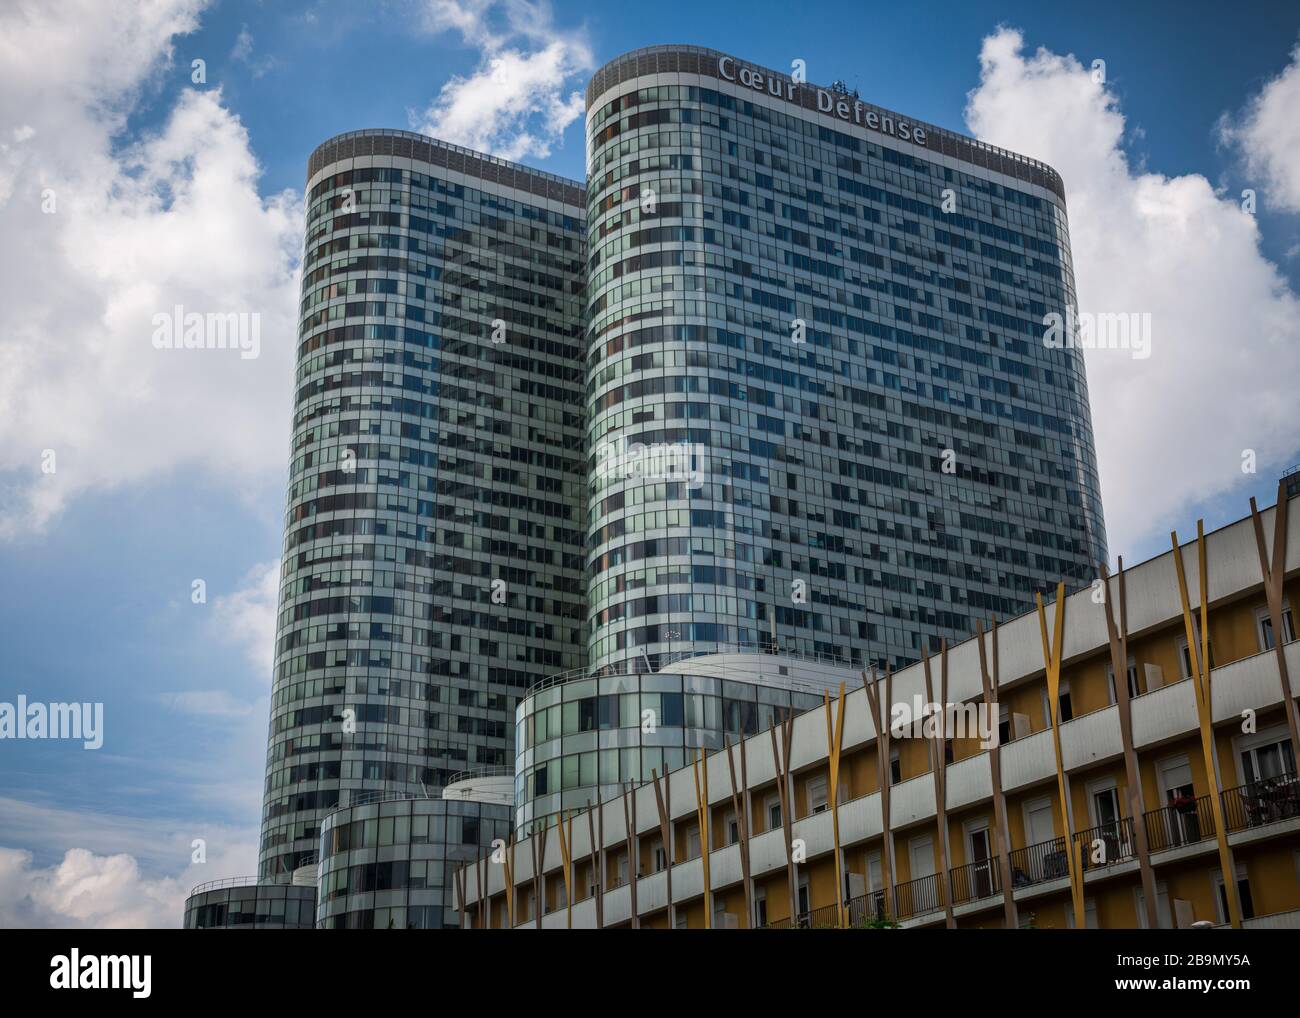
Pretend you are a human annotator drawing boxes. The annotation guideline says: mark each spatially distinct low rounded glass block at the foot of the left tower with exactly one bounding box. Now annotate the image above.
[316,798,511,930]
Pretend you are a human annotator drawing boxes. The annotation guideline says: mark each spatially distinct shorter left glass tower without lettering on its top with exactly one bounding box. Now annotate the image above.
[260,131,585,879]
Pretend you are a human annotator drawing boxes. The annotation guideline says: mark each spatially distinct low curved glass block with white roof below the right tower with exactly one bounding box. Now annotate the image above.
[515,654,837,836]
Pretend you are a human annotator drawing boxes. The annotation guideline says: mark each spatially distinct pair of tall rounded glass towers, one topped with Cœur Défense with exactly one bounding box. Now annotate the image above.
[260,46,1106,924]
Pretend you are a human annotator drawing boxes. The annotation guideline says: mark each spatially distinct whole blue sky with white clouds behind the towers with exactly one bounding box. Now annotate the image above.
[0,0,1300,924]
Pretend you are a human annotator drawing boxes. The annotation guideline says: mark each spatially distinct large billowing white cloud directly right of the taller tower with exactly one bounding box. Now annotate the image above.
[966,29,1300,558]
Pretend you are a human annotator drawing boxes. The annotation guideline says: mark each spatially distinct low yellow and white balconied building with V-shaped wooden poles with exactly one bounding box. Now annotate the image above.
[456,486,1300,928]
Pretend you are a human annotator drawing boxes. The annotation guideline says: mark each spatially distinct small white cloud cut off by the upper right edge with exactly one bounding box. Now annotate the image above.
[1221,43,1300,212]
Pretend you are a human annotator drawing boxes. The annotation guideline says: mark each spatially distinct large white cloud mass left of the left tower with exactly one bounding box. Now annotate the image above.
[0,0,302,537]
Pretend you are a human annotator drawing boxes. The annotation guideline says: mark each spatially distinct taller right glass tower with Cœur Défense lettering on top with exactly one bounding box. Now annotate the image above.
[585,47,1106,670]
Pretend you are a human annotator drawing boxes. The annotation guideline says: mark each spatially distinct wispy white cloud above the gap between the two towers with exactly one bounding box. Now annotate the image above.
[412,0,593,160]
